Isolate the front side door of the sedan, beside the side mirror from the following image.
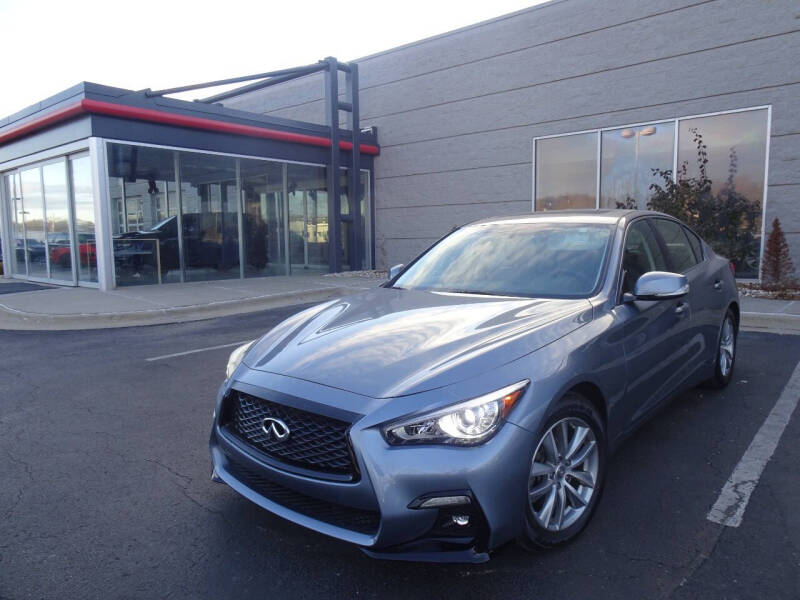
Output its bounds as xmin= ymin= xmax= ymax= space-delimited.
xmin=617 ymin=218 xmax=692 ymax=428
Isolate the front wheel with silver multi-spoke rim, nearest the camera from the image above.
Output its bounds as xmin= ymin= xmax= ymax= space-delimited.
xmin=519 ymin=392 xmax=607 ymax=550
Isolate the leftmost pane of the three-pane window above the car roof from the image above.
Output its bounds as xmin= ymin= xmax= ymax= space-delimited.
xmin=535 ymin=132 xmax=597 ymax=210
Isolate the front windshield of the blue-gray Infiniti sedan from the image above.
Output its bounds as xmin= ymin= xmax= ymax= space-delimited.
xmin=392 ymin=222 xmax=612 ymax=298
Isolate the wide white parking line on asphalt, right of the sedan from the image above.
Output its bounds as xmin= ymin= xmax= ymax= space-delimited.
xmin=706 ymin=363 xmax=800 ymax=527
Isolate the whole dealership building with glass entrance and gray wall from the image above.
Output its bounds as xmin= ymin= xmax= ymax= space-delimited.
xmin=0 ymin=0 xmax=800 ymax=289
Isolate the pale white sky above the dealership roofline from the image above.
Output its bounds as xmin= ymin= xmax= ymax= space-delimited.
xmin=0 ymin=0 xmax=545 ymax=116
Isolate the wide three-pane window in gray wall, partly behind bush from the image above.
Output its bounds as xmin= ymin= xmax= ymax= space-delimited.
xmin=534 ymin=108 xmax=769 ymax=278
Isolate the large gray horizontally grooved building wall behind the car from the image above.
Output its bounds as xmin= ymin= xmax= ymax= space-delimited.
xmin=222 ymin=0 xmax=800 ymax=266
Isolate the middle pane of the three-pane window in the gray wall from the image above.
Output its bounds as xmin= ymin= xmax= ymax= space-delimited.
xmin=600 ymin=122 xmax=675 ymax=210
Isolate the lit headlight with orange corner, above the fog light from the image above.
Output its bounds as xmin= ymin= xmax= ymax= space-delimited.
xmin=383 ymin=379 xmax=530 ymax=446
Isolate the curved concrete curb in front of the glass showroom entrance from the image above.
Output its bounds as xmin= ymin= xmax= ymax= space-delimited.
xmin=0 ymin=287 xmax=354 ymax=331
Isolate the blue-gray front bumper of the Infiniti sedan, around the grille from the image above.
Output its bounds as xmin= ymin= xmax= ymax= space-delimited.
xmin=210 ymin=371 xmax=534 ymax=562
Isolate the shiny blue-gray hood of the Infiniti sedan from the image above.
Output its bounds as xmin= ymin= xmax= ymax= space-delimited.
xmin=244 ymin=288 xmax=592 ymax=398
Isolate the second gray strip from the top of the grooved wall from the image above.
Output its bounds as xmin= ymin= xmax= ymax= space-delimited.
xmin=256 ymin=0 xmax=797 ymax=129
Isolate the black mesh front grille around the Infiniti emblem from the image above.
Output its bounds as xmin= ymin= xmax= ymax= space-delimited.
xmin=223 ymin=390 xmax=356 ymax=478
